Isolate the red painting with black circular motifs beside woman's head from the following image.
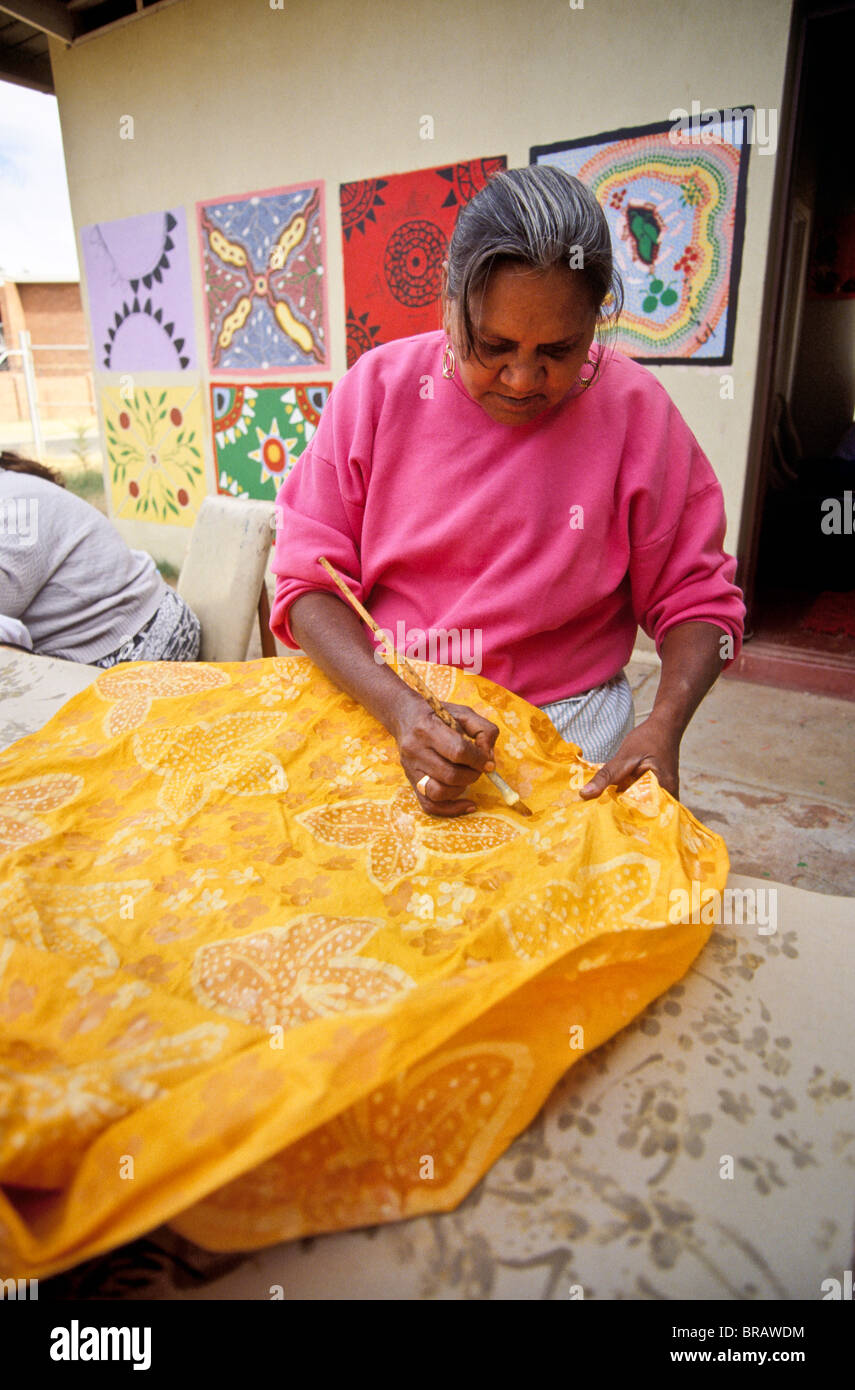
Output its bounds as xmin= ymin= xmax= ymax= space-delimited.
xmin=339 ymin=156 xmax=507 ymax=367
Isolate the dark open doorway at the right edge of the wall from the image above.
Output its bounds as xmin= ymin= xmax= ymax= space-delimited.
xmin=733 ymin=3 xmax=855 ymax=699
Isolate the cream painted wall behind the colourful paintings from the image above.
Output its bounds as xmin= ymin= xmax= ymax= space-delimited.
xmin=51 ymin=0 xmax=791 ymax=563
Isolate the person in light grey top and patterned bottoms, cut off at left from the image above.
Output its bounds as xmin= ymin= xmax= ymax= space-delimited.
xmin=0 ymin=453 xmax=200 ymax=666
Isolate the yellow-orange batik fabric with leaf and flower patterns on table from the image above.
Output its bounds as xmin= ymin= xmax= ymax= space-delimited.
xmin=0 ymin=657 xmax=727 ymax=1277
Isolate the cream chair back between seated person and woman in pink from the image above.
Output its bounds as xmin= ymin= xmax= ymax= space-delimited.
xmin=175 ymin=496 xmax=275 ymax=662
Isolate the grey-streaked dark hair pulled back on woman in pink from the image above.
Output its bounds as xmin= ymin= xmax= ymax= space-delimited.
xmin=445 ymin=164 xmax=623 ymax=377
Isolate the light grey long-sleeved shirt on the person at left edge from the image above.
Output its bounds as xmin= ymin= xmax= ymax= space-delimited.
xmin=0 ymin=467 xmax=165 ymax=662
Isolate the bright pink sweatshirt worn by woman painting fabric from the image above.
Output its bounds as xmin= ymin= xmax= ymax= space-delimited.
xmin=271 ymin=332 xmax=745 ymax=705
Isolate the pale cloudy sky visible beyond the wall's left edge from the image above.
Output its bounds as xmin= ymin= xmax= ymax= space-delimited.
xmin=0 ymin=82 xmax=79 ymax=279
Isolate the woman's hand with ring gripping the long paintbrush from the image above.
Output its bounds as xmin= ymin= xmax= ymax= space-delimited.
xmin=393 ymin=699 xmax=499 ymax=816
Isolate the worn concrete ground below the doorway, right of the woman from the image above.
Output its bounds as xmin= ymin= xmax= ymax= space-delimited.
xmin=627 ymin=649 xmax=855 ymax=895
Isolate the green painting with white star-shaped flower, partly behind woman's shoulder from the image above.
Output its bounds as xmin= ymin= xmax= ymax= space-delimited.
xmin=211 ymin=381 xmax=329 ymax=502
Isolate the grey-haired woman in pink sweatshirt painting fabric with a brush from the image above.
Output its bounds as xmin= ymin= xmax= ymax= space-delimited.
xmin=271 ymin=165 xmax=745 ymax=816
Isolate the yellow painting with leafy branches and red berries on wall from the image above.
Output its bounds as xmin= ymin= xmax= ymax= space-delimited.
xmin=101 ymin=386 xmax=207 ymax=527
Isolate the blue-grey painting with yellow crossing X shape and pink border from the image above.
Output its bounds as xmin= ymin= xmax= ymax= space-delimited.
xmin=197 ymin=183 xmax=329 ymax=375
